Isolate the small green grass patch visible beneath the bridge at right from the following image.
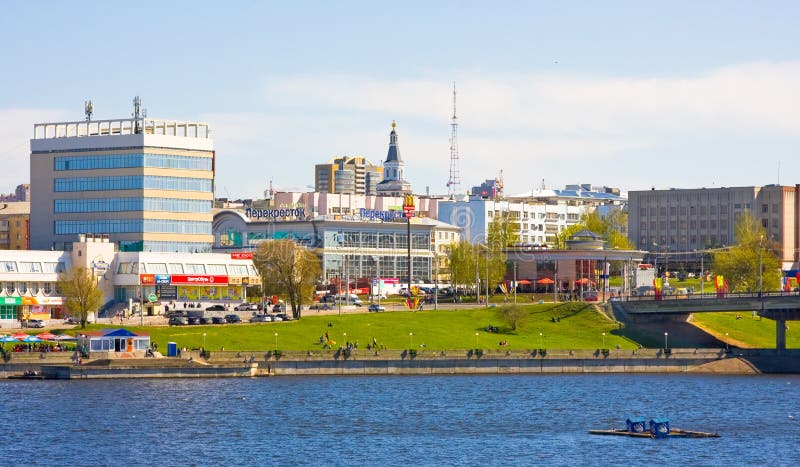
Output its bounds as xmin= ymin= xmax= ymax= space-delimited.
xmin=692 ymin=311 xmax=800 ymax=348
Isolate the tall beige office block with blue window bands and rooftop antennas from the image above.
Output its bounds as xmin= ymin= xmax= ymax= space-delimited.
xmin=30 ymin=117 xmax=215 ymax=252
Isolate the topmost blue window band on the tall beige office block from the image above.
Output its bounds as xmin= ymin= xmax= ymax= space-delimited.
xmin=53 ymin=153 xmax=211 ymax=171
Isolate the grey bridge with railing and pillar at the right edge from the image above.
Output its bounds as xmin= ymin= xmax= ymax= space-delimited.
xmin=611 ymin=292 xmax=800 ymax=351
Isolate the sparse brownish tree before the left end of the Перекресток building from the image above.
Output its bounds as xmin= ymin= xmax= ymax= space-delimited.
xmin=253 ymin=240 xmax=322 ymax=319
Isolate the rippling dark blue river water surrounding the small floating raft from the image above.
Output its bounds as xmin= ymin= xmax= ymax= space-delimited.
xmin=0 ymin=375 xmax=800 ymax=466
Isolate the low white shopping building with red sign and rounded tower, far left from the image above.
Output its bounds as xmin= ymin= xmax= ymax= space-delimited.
xmin=0 ymin=235 xmax=261 ymax=327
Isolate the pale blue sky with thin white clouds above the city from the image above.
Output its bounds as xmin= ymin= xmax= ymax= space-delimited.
xmin=0 ymin=0 xmax=800 ymax=198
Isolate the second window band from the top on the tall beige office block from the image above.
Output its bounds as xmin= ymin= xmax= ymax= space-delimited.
xmin=53 ymin=175 xmax=211 ymax=192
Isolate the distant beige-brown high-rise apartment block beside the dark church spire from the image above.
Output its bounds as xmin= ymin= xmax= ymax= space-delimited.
xmin=314 ymin=156 xmax=383 ymax=195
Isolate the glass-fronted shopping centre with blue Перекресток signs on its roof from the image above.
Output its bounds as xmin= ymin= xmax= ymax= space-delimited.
xmin=214 ymin=208 xmax=460 ymax=283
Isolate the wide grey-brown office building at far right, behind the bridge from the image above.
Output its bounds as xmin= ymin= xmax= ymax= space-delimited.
xmin=628 ymin=185 xmax=800 ymax=270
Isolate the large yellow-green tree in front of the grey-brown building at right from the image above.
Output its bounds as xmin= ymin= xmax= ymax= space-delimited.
xmin=713 ymin=211 xmax=781 ymax=292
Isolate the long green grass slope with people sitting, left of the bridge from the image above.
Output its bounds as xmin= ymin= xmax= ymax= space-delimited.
xmin=72 ymin=303 xmax=637 ymax=351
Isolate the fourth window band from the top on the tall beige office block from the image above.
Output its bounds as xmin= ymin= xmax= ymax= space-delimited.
xmin=54 ymin=219 xmax=211 ymax=235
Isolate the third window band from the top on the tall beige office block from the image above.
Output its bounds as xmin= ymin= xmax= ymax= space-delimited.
xmin=54 ymin=198 xmax=212 ymax=213
